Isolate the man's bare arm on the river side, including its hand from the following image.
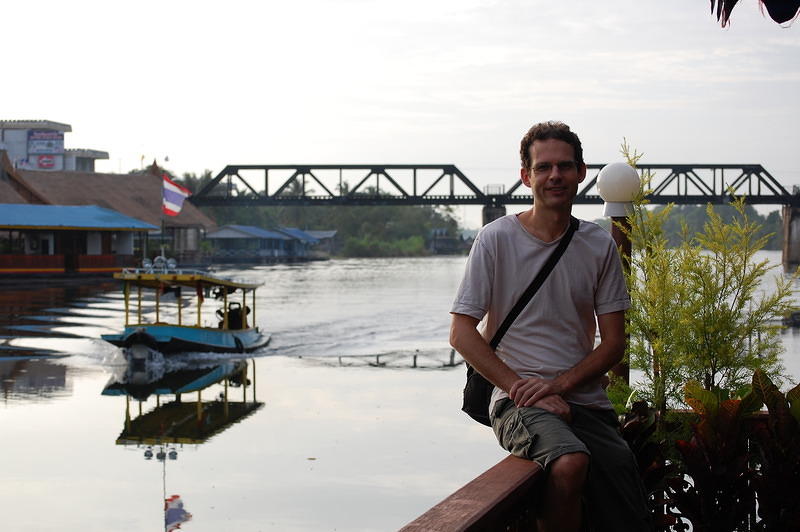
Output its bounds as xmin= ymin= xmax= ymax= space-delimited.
xmin=450 ymin=314 xmax=576 ymax=421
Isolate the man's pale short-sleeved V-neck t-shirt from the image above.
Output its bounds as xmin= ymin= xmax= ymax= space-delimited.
xmin=450 ymin=214 xmax=630 ymax=408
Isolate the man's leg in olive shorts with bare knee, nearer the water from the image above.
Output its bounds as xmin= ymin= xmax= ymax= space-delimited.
xmin=492 ymin=399 xmax=589 ymax=532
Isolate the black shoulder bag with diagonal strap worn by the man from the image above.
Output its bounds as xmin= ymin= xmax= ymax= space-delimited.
xmin=461 ymin=216 xmax=579 ymax=427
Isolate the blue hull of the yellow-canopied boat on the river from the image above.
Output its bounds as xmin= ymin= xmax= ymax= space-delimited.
xmin=102 ymin=325 xmax=270 ymax=355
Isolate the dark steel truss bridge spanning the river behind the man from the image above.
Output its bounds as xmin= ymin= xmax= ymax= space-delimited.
xmin=190 ymin=164 xmax=800 ymax=207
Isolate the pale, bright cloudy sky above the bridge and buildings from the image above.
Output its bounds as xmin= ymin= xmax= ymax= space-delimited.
xmin=0 ymin=0 xmax=800 ymax=226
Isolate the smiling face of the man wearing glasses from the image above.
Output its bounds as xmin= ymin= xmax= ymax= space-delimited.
xmin=520 ymin=139 xmax=586 ymax=208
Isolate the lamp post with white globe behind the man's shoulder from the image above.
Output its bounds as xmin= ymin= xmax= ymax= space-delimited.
xmin=597 ymin=162 xmax=641 ymax=383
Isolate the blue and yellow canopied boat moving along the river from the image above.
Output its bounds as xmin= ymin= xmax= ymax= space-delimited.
xmin=102 ymin=257 xmax=270 ymax=360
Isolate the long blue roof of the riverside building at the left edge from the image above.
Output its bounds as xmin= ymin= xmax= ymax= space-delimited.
xmin=0 ymin=203 xmax=158 ymax=231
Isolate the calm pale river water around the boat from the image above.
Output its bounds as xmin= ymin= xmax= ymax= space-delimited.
xmin=0 ymin=252 xmax=800 ymax=531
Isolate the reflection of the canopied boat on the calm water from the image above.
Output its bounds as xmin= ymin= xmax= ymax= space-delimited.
xmin=102 ymin=360 xmax=264 ymax=446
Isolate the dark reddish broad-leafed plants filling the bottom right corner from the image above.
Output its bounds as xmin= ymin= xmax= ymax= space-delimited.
xmin=665 ymin=370 xmax=800 ymax=532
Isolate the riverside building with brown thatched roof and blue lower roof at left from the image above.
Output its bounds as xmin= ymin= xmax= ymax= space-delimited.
xmin=0 ymin=150 xmax=216 ymax=274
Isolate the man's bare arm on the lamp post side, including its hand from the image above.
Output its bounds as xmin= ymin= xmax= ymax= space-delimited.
xmin=508 ymin=310 xmax=626 ymax=406
